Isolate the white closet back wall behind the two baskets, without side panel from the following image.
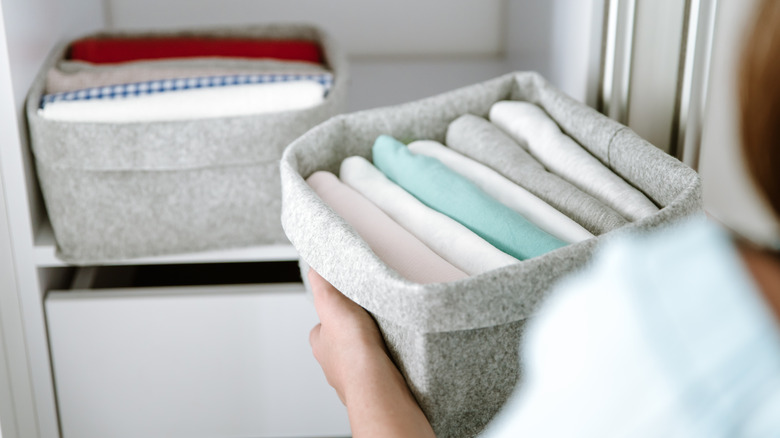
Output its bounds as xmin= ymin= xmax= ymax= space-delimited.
xmin=106 ymin=0 xmax=516 ymax=111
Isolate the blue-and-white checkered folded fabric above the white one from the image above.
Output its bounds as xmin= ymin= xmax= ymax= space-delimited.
xmin=40 ymin=73 xmax=333 ymax=108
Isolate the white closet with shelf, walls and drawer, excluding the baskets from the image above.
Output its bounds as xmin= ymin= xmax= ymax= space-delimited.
xmin=0 ymin=0 xmax=720 ymax=438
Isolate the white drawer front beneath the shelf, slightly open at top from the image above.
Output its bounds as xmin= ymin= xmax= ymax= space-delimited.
xmin=45 ymin=284 xmax=350 ymax=438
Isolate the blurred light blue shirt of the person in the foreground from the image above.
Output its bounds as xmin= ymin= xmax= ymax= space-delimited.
xmin=482 ymin=222 xmax=780 ymax=438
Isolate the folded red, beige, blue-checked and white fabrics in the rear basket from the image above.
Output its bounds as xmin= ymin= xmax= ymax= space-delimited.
xmin=38 ymin=36 xmax=333 ymax=123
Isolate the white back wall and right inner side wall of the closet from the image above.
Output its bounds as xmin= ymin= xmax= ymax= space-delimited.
xmin=106 ymin=0 xmax=603 ymax=111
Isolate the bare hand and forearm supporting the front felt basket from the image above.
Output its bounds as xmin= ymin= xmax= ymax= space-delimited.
xmin=309 ymin=270 xmax=434 ymax=438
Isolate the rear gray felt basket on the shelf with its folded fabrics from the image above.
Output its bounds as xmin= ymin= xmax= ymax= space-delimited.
xmin=26 ymin=24 xmax=348 ymax=264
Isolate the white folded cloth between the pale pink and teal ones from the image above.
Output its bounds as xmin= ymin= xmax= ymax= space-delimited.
xmin=339 ymin=156 xmax=518 ymax=275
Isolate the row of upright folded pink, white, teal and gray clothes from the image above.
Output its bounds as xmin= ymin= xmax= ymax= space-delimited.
xmin=306 ymin=101 xmax=658 ymax=283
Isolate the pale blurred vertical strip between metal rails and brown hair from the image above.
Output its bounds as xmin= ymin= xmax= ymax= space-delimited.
xmin=699 ymin=0 xmax=780 ymax=242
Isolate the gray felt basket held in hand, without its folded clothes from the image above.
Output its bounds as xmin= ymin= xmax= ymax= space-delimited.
xmin=281 ymin=73 xmax=701 ymax=437
